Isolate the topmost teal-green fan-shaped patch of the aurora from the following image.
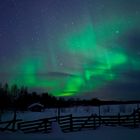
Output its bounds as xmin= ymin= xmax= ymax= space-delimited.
xmin=62 ymin=25 xmax=96 ymax=55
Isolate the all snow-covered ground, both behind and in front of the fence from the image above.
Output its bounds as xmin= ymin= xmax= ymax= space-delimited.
xmin=0 ymin=104 xmax=140 ymax=140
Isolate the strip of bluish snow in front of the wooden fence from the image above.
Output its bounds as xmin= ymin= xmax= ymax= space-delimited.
xmin=0 ymin=127 xmax=140 ymax=140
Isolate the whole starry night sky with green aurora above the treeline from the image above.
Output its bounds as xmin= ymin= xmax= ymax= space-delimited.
xmin=0 ymin=0 xmax=140 ymax=99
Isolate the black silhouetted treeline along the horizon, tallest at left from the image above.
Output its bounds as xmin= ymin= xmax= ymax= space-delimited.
xmin=0 ymin=83 xmax=140 ymax=111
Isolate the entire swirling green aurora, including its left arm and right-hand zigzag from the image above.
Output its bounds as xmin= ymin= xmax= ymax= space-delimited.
xmin=9 ymin=21 xmax=127 ymax=96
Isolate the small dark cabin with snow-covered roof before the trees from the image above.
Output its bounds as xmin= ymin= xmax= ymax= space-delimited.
xmin=28 ymin=103 xmax=44 ymax=112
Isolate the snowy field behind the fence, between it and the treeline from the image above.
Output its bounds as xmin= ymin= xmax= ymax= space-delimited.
xmin=1 ymin=104 xmax=140 ymax=121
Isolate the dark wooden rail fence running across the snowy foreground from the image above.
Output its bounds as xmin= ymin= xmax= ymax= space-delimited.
xmin=0 ymin=108 xmax=140 ymax=133
